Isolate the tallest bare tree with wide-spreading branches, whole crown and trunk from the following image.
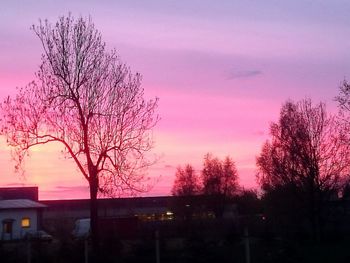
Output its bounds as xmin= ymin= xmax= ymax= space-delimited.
xmin=1 ymin=15 xmax=158 ymax=251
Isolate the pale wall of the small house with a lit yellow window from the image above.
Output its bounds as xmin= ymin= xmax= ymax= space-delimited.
xmin=0 ymin=209 xmax=38 ymax=240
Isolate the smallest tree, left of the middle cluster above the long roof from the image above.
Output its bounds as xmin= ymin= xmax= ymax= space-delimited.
xmin=171 ymin=164 xmax=200 ymax=196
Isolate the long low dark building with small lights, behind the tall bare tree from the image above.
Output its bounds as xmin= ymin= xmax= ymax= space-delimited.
xmin=41 ymin=196 xmax=238 ymax=238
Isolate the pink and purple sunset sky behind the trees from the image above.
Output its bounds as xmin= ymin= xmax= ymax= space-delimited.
xmin=0 ymin=0 xmax=350 ymax=199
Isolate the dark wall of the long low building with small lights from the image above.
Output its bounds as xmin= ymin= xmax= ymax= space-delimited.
xmin=41 ymin=196 xmax=238 ymax=240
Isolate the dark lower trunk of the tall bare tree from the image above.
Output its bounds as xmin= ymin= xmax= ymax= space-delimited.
xmin=89 ymin=175 xmax=99 ymax=258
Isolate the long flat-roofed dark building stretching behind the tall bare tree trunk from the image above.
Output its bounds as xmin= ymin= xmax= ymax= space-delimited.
xmin=41 ymin=196 xmax=230 ymax=224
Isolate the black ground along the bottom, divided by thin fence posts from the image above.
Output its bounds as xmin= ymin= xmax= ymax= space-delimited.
xmin=0 ymin=236 xmax=350 ymax=263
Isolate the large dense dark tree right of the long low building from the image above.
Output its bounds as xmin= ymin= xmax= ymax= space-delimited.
xmin=257 ymin=99 xmax=350 ymax=241
